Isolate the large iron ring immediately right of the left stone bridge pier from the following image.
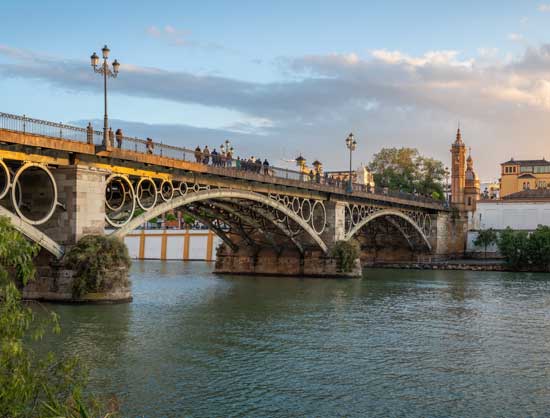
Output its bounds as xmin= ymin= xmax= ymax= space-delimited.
xmin=105 ymin=174 xmax=137 ymax=228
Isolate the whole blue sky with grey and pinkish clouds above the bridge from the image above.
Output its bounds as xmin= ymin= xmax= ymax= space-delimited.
xmin=0 ymin=0 xmax=550 ymax=180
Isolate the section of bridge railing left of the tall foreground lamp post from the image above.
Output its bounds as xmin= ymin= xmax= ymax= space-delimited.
xmin=0 ymin=112 xmax=103 ymax=144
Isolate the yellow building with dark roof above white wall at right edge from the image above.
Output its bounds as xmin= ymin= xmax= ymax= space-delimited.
xmin=500 ymin=158 xmax=550 ymax=198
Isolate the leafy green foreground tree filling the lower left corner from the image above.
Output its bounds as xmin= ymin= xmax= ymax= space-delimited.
xmin=0 ymin=217 xmax=116 ymax=418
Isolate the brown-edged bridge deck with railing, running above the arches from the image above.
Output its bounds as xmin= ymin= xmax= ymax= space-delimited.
xmin=0 ymin=113 xmax=447 ymax=211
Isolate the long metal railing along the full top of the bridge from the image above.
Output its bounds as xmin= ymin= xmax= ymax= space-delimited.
xmin=0 ymin=112 xmax=447 ymax=208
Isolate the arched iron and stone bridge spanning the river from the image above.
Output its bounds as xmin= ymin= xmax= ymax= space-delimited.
xmin=0 ymin=113 xmax=463 ymax=298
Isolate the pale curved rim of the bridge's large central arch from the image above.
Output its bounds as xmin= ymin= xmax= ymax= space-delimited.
xmin=111 ymin=189 xmax=328 ymax=253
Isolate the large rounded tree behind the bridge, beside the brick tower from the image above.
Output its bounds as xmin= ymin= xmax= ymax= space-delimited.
xmin=369 ymin=148 xmax=445 ymax=199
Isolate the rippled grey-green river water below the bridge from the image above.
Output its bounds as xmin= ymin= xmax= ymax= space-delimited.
xmin=41 ymin=261 xmax=550 ymax=417
